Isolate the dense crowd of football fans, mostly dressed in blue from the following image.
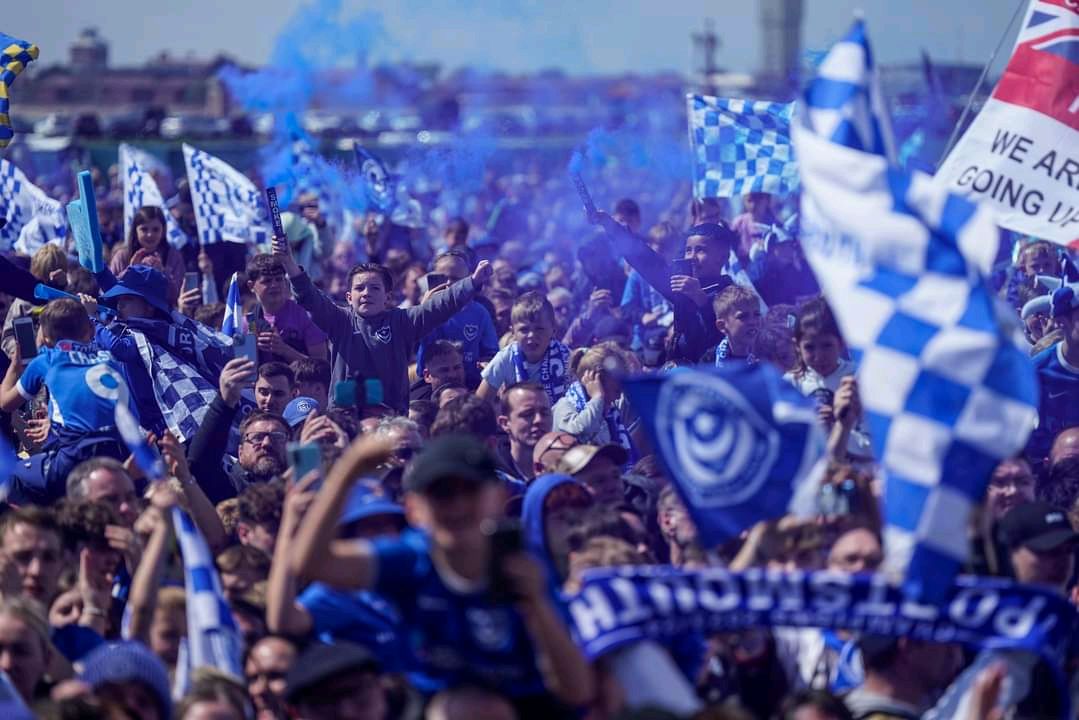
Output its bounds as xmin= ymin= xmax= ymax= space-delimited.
xmin=0 ymin=147 xmax=1079 ymax=720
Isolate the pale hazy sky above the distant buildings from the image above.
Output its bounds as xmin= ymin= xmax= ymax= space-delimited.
xmin=0 ymin=0 xmax=1026 ymax=74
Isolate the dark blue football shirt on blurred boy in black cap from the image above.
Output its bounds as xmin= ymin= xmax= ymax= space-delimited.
xmin=373 ymin=531 xmax=546 ymax=697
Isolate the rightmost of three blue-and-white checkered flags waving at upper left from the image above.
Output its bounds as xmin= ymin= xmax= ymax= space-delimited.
xmin=183 ymin=145 xmax=273 ymax=245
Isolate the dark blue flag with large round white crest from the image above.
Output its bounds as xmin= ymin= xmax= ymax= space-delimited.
xmin=624 ymin=363 xmax=824 ymax=546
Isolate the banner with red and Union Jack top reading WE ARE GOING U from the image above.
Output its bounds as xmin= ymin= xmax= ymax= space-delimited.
xmin=938 ymin=0 xmax=1079 ymax=244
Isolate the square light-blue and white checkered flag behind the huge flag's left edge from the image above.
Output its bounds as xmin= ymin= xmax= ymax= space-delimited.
xmin=686 ymin=95 xmax=798 ymax=198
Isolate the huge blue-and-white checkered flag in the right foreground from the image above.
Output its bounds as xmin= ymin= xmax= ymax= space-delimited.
xmin=792 ymin=21 xmax=1038 ymax=601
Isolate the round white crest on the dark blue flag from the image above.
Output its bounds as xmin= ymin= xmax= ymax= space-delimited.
xmin=656 ymin=372 xmax=780 ymax=508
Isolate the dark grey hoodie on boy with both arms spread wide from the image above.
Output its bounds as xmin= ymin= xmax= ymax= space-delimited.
xmin=292 ymin=272 xmax=476 ymax=413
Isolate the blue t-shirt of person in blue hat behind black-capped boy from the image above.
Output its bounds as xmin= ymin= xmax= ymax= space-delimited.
xmin=297 ymin=583 xmax=408 ymax=673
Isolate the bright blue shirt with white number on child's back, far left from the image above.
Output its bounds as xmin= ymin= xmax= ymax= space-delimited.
xmin=15 ymin=340 xmax=129 ymax=432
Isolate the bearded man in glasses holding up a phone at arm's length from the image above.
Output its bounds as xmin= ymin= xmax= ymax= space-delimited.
xmin=188 ymin=357 xmax=288 ymax=505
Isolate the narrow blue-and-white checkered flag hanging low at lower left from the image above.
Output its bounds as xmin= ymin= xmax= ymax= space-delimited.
xmin=173 ymin=507 xmax=244 ymax=694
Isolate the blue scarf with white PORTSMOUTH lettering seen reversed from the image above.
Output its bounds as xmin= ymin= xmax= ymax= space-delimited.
xmin=566 ymin=566 xmax=1079 ymax=706
